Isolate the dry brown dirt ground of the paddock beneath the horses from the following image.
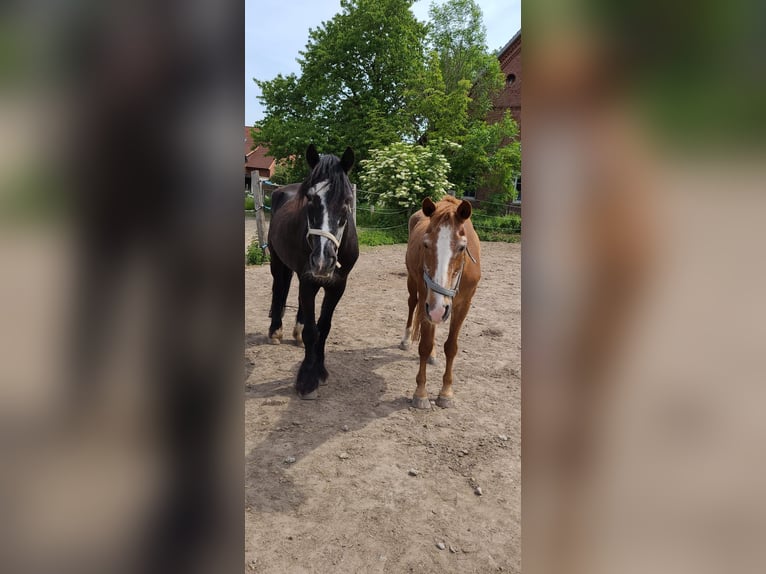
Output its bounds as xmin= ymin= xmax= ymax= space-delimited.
xmin=245 ymin=221 xmax=521 ymax=574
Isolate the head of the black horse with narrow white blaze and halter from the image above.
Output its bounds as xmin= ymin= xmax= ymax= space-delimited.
xmin=300 ymin=144 xmax=354 ymax=279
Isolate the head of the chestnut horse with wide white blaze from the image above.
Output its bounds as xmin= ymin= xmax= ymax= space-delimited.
xmin=422 ymin=196 xmax=471 ymax=323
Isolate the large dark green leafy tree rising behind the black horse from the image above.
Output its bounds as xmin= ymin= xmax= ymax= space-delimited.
xmin=255 ymin=0 xmax=426 ymax=176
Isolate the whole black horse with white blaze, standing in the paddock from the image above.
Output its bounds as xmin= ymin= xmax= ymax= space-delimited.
xmin=269 ymin=144 xmax=359 ymax=399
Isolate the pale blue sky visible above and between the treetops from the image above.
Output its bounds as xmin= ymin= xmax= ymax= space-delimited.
xmin=245 ymin=0 xmax=521 ymax=125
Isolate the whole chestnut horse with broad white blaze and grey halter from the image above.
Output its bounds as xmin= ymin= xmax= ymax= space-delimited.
xmin=400 ymin=196 xmax=481 ymax=409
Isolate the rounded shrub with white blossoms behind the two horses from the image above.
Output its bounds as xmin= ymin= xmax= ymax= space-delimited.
xmin=359 ymin=143 xmax=451 ymax=211
